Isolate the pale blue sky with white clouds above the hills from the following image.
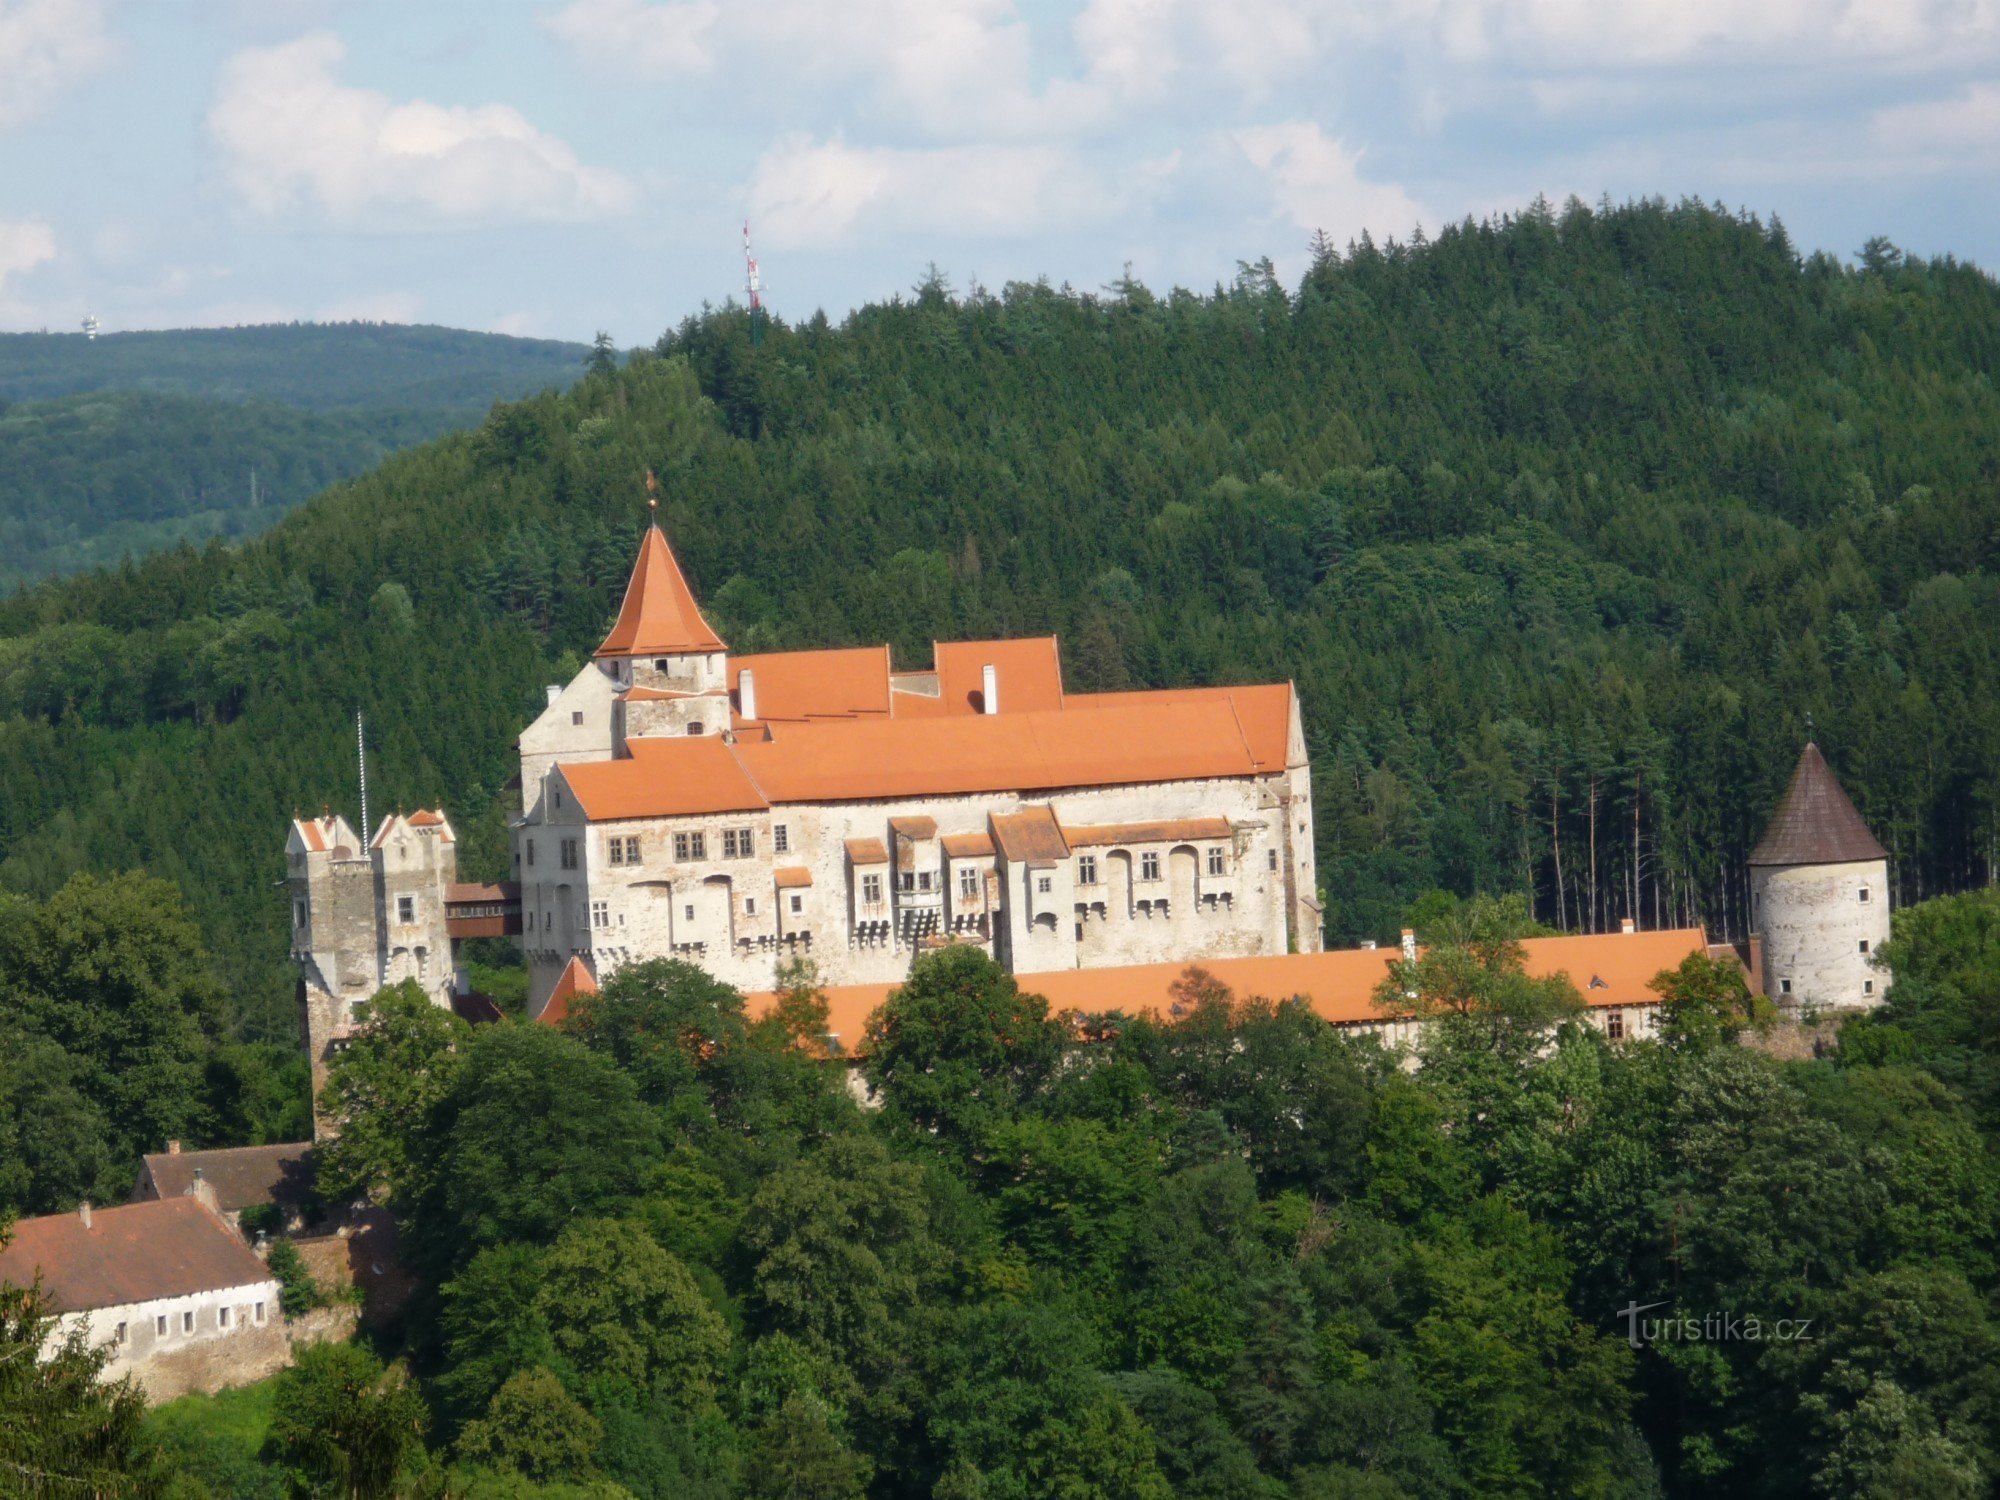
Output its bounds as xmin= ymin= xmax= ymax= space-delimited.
xmin=0 ymin=0 xmax=2000 ymax=346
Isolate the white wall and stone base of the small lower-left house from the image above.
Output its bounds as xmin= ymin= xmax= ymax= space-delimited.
xmin=50 ymin=1280 xmax=288 ymax=1402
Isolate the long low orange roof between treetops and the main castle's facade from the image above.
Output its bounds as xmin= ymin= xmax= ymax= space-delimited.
xmin=750 ymin=928 xmax=1708 ymax=1054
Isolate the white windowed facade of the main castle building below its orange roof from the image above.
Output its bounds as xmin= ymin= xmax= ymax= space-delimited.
xmin=516 ymin=772 xmax=1318 ymax=1008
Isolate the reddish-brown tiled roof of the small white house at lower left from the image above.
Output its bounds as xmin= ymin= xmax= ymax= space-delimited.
xmin=0 ymin=1198 xmax=272 ymax=1312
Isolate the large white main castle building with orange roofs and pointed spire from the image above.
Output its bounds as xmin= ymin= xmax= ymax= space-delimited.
xmin=514 ymin=526 xmax=1320 ymax=1012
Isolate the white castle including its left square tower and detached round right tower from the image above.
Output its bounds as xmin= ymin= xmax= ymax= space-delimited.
xmin=286 ymin=512 xmax=1888 ymax=1112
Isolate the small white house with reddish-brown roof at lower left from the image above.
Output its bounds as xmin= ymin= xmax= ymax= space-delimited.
xmin=0 ymin=1194 xmax=290 ymax=1402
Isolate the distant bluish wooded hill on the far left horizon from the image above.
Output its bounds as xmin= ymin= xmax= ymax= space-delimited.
xmin=0 ymin=322 xmax=588 ymax=586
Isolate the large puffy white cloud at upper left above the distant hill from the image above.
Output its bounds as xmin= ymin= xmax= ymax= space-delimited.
xmin=208 ymin=32 xmax=632 ymax=228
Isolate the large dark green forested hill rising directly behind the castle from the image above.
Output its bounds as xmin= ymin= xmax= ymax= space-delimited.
xmin=0 ymin=204 xmax=2000 ymax=1032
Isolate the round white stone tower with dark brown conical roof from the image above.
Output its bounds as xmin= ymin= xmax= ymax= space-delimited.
xmin=1750 ymin=744 xmax=1888 ymax=1006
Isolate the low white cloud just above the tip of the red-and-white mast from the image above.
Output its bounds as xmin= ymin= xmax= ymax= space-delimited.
xmin=750 ymin=136 xmax=1116 ymax=248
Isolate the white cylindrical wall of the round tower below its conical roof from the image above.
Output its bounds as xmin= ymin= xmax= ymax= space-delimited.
xmin=1750 ymin=860 xmax=1890 ymax=1006
